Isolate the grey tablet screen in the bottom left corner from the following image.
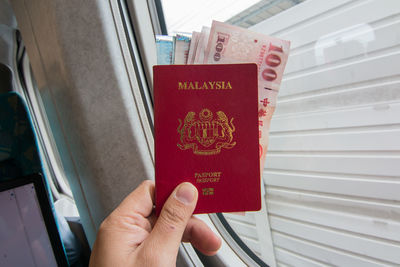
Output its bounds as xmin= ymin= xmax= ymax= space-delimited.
xmin=0 ymin=183 xmax=57 ymax=267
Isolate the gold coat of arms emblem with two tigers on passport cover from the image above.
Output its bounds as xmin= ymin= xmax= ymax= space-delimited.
xmin=177 ymin=108 xmax=236 ymax=155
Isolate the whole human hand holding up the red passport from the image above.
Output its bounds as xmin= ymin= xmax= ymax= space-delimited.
xmin=89 ymin=181 xmax=221 ymax=267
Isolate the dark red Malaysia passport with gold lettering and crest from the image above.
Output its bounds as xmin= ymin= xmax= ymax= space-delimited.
xmin=153 ymin=64 xmax=261 ymax=215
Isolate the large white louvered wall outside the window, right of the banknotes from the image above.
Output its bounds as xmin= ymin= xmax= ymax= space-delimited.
xmin=254 ymin=0 xmax=400 ymax=266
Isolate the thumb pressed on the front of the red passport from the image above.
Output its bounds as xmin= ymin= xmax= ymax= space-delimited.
xmin=146 ymin=183 xmax=198 ymax=264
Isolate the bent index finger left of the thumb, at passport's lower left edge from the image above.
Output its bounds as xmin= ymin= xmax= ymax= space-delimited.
xmin=115 ymin=180 xmax=155 ymax=218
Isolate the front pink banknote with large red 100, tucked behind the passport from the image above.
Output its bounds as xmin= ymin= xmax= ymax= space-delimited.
xmin=203 ymin=21 xmax=290 ymax=168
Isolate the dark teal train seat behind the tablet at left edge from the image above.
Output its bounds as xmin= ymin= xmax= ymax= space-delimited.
xmin=0 ymin=92 xmax=81 ymax=266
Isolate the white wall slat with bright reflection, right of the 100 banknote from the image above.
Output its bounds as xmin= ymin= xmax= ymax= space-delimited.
xmin=285 ymin=15 xmax=400 ymax=75
